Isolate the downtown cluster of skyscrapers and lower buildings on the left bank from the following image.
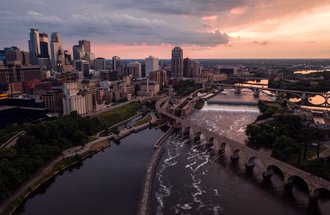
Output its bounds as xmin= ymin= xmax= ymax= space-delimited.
xmin=0 ymin=28 xmax=229 ymax=126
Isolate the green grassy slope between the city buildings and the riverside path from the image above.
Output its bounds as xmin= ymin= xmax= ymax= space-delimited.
xmin=97 ymin=102 xmax=142 ymax=128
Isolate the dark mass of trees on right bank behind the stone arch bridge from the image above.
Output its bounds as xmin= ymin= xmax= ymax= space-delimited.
xmin=246 ymin=101 xmax=330 ymax=180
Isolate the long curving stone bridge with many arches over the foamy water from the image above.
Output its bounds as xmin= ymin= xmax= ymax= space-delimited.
xmin=156 ymin=97 xmax=330 ymax=200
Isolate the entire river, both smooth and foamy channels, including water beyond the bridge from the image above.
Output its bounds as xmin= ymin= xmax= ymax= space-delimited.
xmin=16 ymin=90 xmax=330 ymax=215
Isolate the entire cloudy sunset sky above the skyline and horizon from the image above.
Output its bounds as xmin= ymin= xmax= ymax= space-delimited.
xmin=0 ymin=0 xmax=330 ymax=59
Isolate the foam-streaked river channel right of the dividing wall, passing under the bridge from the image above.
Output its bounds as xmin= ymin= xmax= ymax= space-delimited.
xmin=151 ymin=90 xmax=330 ymax=215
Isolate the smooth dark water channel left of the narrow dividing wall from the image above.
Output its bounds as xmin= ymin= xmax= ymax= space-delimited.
xmin=16 ymin=129 xmax=162 ymax=215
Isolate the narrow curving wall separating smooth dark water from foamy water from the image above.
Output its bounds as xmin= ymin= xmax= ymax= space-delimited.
xmin=138 ymin=128 xmax=174 ymax=215
